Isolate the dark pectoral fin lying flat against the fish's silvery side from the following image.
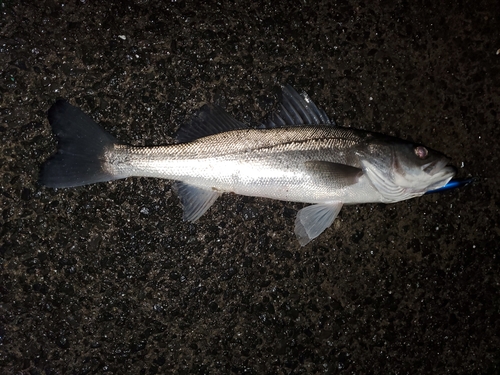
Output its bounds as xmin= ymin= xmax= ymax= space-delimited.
xmin=304 ymin=160 xmax=363 ymax=189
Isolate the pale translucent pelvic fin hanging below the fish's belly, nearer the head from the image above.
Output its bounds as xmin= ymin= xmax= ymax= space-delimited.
xmin=295 ymin=202 xmax=342 ymax=246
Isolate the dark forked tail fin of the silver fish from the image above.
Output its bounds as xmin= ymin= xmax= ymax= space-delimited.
xmin=40 ymin=100 xmax=120 ymax=188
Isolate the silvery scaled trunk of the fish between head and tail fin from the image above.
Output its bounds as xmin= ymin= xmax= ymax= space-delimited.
xmin=106 ymin=126 xmax=390 ymax=204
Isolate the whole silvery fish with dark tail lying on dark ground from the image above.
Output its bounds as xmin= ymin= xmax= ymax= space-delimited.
xmin=40 ymin=85 xmax=456 ymax=246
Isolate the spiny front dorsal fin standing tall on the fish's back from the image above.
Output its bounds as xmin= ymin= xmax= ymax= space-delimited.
xmin=263 ymin=85 xmax=335 ymax=128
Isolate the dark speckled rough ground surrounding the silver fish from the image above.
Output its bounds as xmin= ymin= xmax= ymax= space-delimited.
xmin=0 ymin=0 xmax=500 ymax=374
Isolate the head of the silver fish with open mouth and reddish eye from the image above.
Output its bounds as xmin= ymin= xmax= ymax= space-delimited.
xmin=361 ymin=137 xmax=456 ymax=203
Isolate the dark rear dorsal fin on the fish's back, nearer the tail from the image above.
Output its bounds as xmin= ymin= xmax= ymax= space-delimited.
xmin=176 ymin=104 xmax=247 ymax=143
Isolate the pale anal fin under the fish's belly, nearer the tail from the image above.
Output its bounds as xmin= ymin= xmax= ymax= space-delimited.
xmin=172 ymin=182 xmax=220 ymax=222
